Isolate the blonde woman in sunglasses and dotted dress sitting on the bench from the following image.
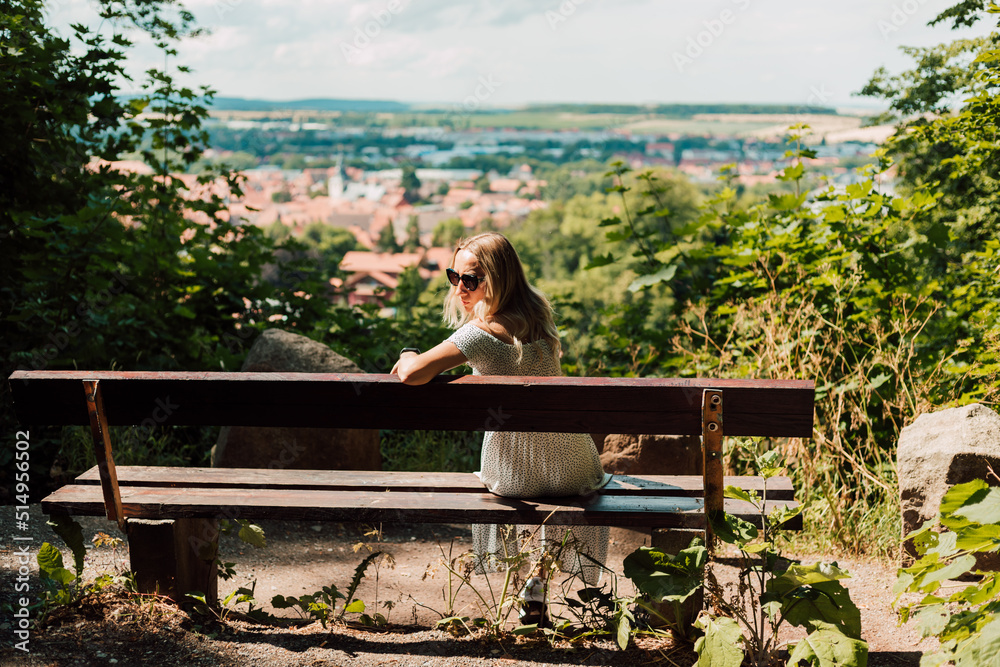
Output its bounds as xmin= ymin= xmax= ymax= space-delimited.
xmin=392 ymin=232 xmax=611 ymax=625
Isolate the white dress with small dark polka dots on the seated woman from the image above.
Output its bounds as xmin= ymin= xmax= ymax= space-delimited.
xmin=448 ymin=322 xmax=611 ymax=584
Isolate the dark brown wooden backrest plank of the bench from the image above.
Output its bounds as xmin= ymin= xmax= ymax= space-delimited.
xmin=10 ymin=371 xmax=814 ymax=437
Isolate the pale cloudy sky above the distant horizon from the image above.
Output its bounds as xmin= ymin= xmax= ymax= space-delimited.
xmin=43 ymin=0 xmax=992 ymax=109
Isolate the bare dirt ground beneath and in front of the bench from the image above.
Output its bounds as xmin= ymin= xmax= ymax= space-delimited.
xmin=0 ymin=507 xmax=934 ymax=667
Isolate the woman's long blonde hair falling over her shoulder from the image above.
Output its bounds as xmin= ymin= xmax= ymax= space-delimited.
xmin=444 ymin=232 xmax=561 ymax=359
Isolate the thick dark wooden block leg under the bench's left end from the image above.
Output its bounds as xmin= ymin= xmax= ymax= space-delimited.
xmin=126 ymin=519 xmax=219 ymax=605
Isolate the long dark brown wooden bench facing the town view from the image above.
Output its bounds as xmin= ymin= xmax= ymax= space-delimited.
xmin=10 ymin=371 xmax=814 ymax=600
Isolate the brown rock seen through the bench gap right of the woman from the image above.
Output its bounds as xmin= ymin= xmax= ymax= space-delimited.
xmin=601 ymin=434 xmax=704 ymax=475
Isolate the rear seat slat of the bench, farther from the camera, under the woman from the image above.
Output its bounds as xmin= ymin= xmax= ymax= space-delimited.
xmin=76 ymin=466 xmax=794 ymax=500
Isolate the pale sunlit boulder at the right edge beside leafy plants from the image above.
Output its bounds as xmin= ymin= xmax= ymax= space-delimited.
xmin=896 ymin=403 xmax=1000 ymax=569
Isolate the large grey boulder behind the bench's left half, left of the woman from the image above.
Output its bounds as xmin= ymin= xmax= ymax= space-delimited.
xmin=212 ymin=329 xmax=382 ymax=470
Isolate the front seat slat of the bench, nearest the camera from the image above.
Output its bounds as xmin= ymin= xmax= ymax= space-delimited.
xmin=42 ymin=484 xmax=801 ymax=528
